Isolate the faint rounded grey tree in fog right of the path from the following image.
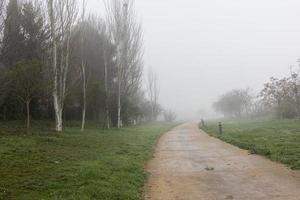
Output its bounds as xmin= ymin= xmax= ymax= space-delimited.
xmin=213 ymin=89 xmax=253 ymax=117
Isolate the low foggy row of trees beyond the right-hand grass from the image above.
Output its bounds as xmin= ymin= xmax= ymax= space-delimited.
xmin=213 ymin=63 xmax=300 ymax=119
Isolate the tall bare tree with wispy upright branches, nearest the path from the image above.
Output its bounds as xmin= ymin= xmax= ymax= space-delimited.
xmin=106 ymin=0 xmax=142 ymax=128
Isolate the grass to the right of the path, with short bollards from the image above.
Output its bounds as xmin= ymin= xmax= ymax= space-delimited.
xmin=201 ymin=120 xmax=300 ymax=169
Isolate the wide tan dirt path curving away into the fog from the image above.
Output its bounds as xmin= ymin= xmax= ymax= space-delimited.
xmin=145 ymin=123 xmax=300 ymax=200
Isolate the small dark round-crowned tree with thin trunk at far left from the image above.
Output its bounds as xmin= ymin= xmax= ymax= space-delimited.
xmin=10 ymin=60 xmax=48 ymax=132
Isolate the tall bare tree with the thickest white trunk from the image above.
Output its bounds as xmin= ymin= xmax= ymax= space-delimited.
xmin=48 ymin=0 xmax=78 ymax=132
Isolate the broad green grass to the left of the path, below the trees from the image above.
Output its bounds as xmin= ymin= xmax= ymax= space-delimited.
xmin=0 ymin=122 xmax=174 ymax=200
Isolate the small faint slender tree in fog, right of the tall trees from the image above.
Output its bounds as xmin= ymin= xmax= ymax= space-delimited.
xmin=147 ymin=68 xmax=159 ymax=121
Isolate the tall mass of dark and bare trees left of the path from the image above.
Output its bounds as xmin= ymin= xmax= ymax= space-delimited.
xmin=0 ymin=0 xmax=169 ymax=132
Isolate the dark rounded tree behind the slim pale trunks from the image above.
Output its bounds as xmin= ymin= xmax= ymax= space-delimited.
xmin=65 ymin=16 xmax=117 ymax=128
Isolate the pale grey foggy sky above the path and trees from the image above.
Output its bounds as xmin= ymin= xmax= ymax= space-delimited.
xmin=88 ymin=0 xmax=300 ymax=119
